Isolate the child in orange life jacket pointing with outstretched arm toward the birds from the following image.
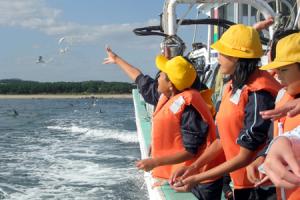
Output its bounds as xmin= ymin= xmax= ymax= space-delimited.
xmin=104 ymin=48 xmax=223 ymax=199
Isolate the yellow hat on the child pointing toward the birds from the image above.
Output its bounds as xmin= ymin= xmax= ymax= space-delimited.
xmin=156 ymin=55 xmax=197 ymax=91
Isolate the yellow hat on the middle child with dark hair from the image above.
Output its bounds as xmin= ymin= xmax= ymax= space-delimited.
xmin=211 ymin=24 xmax=263 ymax=58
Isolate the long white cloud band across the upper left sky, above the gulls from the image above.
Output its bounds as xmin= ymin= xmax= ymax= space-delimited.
xmin=0 ymin=0 xmax=159 ymax=43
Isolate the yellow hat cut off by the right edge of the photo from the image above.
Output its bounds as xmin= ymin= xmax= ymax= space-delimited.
xmin=260 ymin=33 xmax=300 ymax=70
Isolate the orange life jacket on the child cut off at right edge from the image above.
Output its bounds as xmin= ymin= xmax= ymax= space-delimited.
xmin=274 ymin=89 xmax=300 ymax=200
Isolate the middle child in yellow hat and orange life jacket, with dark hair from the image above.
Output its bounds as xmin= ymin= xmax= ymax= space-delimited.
xmin=174 ymin=24 xmax=280 ymax=200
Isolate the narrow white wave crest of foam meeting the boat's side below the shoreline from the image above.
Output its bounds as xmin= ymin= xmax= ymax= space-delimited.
xmin=47 ymin=124 xmax=138 ymax=143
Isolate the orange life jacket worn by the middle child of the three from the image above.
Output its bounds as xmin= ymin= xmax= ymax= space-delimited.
xmin=216 ymin=70 xmax=280 ymax=189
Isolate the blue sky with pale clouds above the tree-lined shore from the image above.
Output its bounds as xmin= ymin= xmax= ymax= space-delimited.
xmin=0 ymin=0 xmax=206 ymax=82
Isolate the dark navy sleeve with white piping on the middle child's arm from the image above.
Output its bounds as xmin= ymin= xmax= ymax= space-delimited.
xmin=237 ymin=91 xmax=274 ymax=151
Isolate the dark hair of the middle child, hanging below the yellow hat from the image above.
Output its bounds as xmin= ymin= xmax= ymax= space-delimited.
xmin=231 ymin=58 xmax=260 ymax=94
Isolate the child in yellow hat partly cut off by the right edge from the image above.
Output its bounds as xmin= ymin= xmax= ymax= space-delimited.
xmin=261 ymin=33 xmax=300 ymax=200
